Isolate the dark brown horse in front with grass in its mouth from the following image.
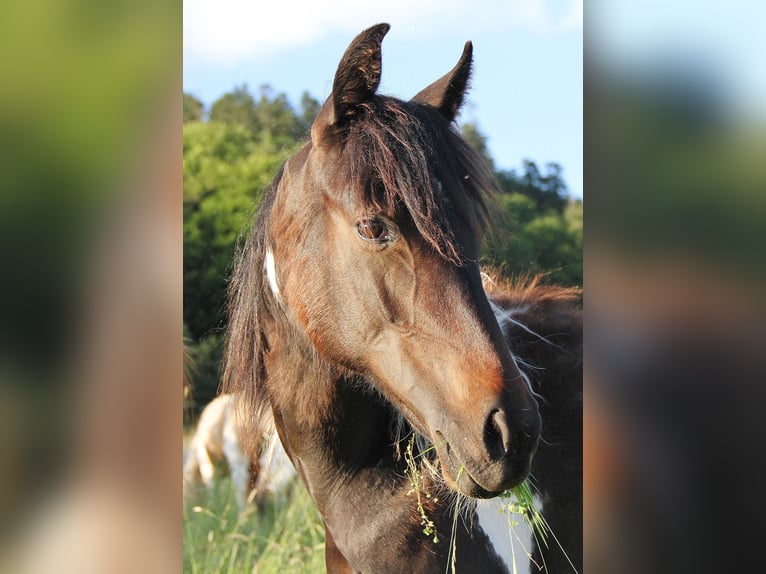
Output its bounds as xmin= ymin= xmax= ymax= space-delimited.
xmin=224 ymin=24 xmax=581 ymax=573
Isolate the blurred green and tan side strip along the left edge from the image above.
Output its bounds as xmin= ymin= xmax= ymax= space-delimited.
xmin=0 ymin=0 xmax=182 ymax=572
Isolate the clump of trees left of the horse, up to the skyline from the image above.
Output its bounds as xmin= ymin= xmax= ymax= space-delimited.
xmin=183 ymin=85 xmax=319 ymax=405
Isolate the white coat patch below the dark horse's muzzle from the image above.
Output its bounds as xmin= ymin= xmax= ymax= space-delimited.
xmin=476 ymin=496 xmax=543 ymax=574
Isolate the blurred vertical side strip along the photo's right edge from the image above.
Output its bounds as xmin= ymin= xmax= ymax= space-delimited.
xmin=584 ymin=0 xmax=766 ymax=572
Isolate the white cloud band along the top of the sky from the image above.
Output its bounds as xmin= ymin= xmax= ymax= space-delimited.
xmin=184 ymin=0 xmax=582 ymax=63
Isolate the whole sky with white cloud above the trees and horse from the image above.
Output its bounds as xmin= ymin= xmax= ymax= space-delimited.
xmin=183 ymin=0 xmax=583 ymax=197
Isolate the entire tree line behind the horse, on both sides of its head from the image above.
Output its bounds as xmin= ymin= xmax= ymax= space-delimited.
xmin=183 ymin=85 xmax=582 ymax=418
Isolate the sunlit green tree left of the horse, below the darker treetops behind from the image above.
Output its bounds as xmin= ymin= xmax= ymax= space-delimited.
xmin=183 ymin=122 xmax=302 ymax=407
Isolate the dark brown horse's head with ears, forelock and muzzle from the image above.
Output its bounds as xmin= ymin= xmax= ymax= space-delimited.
xmin=265 ymin=24 xmax=540 ymax=498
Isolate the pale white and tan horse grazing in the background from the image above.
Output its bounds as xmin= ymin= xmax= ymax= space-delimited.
xmin=183 ymin=394 xmax=295 ymax=510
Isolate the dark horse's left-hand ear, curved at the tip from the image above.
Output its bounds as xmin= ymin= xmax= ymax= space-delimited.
xmin=311 ymin=24 xmax=391 ymax=140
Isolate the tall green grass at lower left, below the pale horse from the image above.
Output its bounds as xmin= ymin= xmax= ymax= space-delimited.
xmin=183 ymin=477 xmax=325 ymax=574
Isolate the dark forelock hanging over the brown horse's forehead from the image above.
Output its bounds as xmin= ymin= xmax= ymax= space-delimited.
xmin=336 ymin=96 xmax=496 ymax=264
